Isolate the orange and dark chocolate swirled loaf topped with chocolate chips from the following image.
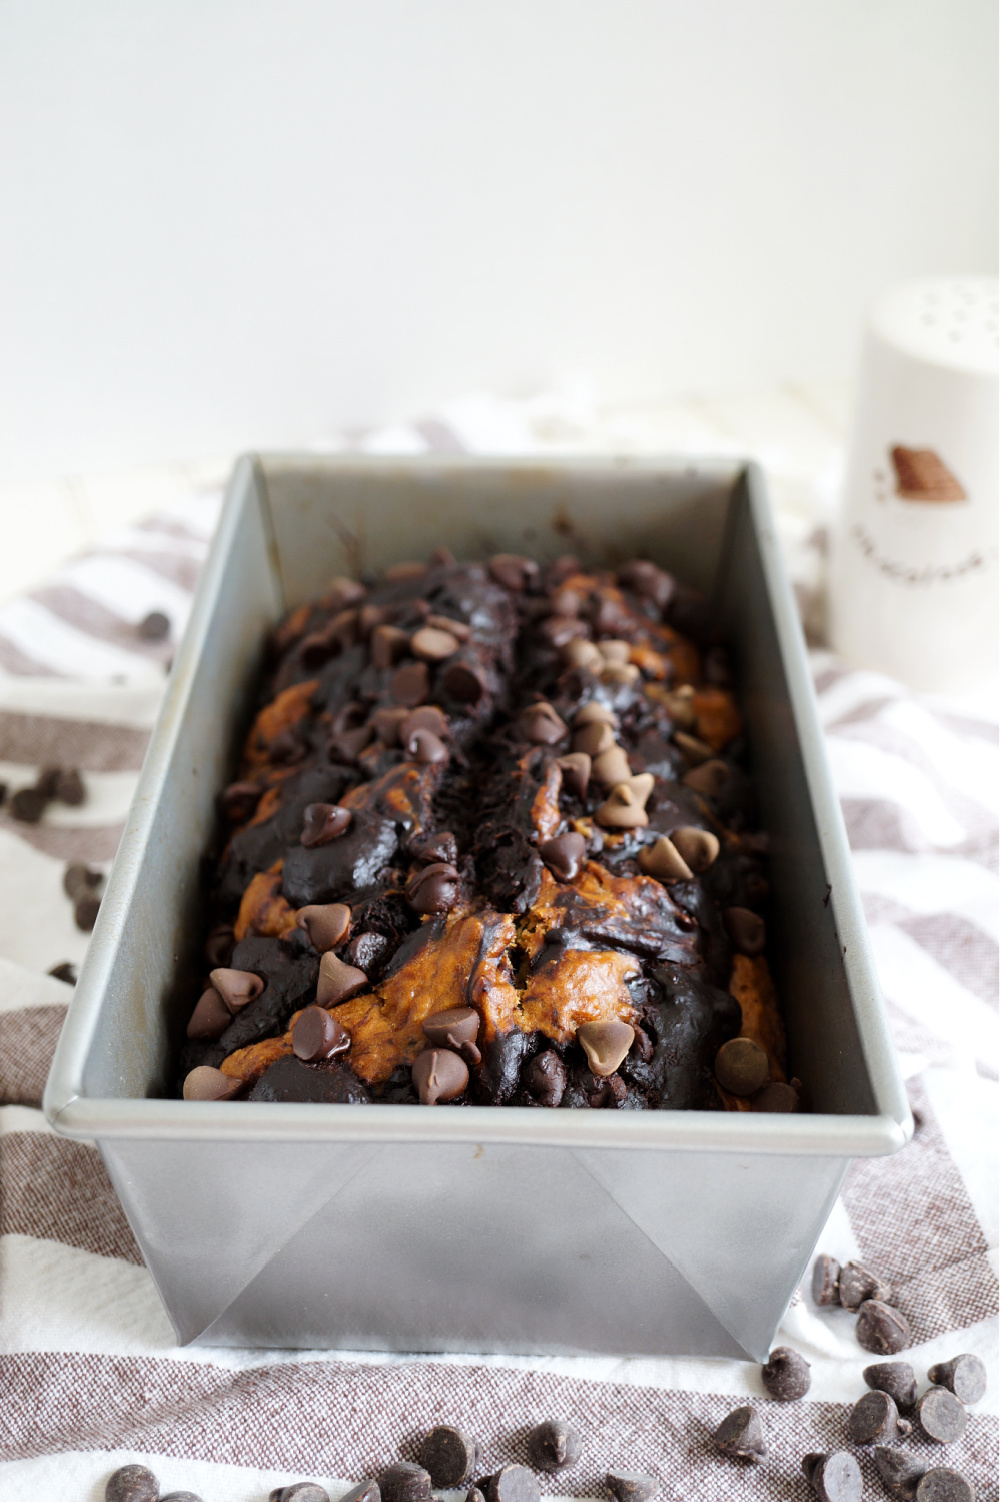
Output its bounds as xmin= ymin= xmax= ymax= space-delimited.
xmin=179 ymin=551 xmax=799 ymax=1110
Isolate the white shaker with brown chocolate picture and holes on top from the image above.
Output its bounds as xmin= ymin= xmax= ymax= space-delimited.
xmin=829 ymin=276 xmax=1000 ymax=691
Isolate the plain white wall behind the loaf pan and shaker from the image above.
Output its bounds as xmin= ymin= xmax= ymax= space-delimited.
xmin=0 ymin=0 xmax=997 ymax=479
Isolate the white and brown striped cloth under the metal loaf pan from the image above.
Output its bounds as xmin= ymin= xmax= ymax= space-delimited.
xmin=0 ymin=424 xmax=998 ymax=1502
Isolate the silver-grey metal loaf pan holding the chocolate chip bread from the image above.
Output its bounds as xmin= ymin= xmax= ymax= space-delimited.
xmin=45 ymin=457 xmax=911 ymax=1359
